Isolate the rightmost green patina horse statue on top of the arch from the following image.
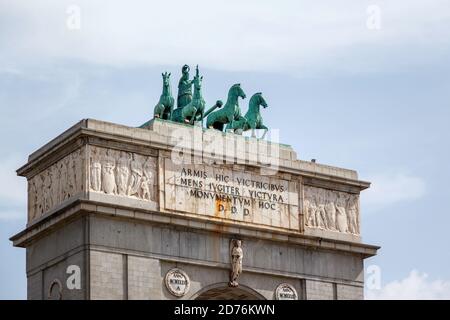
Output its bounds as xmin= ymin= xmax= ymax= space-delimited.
xmin=227 ymin=92 xmax=268 ymax=139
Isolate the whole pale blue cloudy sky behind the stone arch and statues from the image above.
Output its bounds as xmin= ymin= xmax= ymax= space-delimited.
xmin=0 ymin=0 xmax=450 ymax=299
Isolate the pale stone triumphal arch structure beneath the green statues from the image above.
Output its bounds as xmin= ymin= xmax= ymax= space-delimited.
xmin=11 ymin=119 xmax=378 ymax=299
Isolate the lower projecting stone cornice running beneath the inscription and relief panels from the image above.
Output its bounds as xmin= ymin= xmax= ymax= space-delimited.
xmin=10 ymin=200 xmax=380 ymax=258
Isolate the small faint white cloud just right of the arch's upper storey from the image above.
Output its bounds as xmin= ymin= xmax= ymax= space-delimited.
xmin=361 ymin=173 xmax=426 ymax=208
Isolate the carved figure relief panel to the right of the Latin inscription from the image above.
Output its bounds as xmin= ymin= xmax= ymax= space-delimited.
xmin=303 ymin=186 xmax=360 ymax=235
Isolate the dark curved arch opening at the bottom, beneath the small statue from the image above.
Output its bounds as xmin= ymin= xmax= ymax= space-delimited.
xmin=191 ymin=282 xmax=266 ymax=300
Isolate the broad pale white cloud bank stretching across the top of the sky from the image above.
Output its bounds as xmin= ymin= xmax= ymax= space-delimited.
xmin=0 ymin=0 xmax=450 ymax=73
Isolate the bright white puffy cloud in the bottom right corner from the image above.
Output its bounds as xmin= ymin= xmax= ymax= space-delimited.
xmin=365 ymin=270 xmax=450 ymax=300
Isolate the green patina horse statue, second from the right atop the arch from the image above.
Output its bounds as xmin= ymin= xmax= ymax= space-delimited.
xmin=206 ymin=83 xmax=246 ymax=131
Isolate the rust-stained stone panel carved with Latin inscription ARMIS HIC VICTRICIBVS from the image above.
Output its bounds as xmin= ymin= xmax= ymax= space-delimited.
xmin=164 ymin=159 xmax=299 ymax=230
